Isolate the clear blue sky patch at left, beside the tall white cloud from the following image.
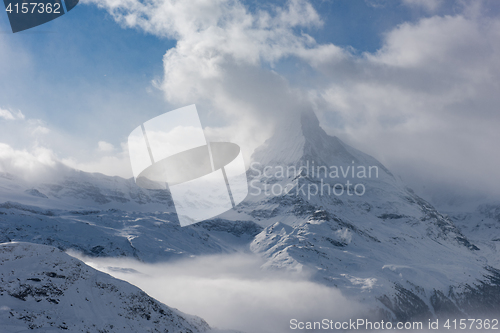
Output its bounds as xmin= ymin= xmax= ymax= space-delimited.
xmin=0 ymin=5 xmax=170 ymax=142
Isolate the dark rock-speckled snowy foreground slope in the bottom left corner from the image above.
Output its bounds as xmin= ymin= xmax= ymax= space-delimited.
xmin=0 ymin=243 xmax=210 ymax=333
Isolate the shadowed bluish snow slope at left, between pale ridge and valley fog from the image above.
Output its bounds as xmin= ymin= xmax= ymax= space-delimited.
xmin=0 ymin=202 xmax=262 ymax=262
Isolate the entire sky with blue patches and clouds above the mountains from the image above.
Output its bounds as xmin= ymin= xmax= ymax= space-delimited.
xmin=0 ymin=0 xmax=500 ymax=206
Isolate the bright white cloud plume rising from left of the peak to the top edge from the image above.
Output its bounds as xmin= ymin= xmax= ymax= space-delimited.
xmin=82 ymin=0 xmax=346 ymax=160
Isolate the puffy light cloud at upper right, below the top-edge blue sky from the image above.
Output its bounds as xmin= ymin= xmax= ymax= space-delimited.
xmin=368 ymin=15 xmax=488 ymax=68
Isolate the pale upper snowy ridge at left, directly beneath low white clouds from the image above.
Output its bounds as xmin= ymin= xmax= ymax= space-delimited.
xmin=0 ymin=165 xmax=174 ymax=212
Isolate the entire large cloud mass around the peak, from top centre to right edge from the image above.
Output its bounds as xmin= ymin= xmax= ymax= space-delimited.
xmin=81 ymin=0 xmax=500 ymax=205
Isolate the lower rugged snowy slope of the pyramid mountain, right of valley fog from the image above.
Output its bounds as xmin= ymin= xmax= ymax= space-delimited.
xmin=251 ymin=211 xmax=500 ymax=320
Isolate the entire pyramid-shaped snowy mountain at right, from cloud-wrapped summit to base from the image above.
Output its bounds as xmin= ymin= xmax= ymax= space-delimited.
xmin=237 ymin=112 xmax=500 ymax=320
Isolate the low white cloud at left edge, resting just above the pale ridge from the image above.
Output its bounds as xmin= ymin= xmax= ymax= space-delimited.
xmin=0 ymin=109 xmax=132 ymax=181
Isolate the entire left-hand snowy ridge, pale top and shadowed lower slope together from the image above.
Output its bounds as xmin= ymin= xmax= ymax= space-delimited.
xmin=0 ymin=161 xmax=262 ymax=262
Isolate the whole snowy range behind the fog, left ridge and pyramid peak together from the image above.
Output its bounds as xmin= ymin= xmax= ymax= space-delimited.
xmin=0 ymin=112 xmax=500 ymax=320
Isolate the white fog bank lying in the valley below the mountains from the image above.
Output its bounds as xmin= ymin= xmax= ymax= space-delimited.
xmin=71 ymin=253 xmax=366 ymax=333
